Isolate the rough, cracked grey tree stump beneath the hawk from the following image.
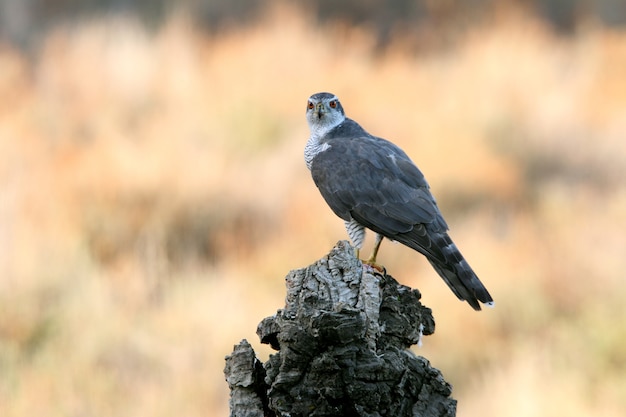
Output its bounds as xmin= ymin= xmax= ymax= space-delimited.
xmin=225 ymin=241 xmax=456 ymax=417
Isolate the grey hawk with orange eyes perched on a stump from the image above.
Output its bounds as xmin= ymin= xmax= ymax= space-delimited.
xmin=304 ymin=93 xmax=493 ymax=310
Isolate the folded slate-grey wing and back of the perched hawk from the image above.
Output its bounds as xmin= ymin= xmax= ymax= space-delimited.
xmin=311 ymin=136 xmax=448 ymax=244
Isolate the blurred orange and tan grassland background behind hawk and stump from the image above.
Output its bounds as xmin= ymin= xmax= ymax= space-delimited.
xmin=0 ymin=0 xmax=626 ymax=417
